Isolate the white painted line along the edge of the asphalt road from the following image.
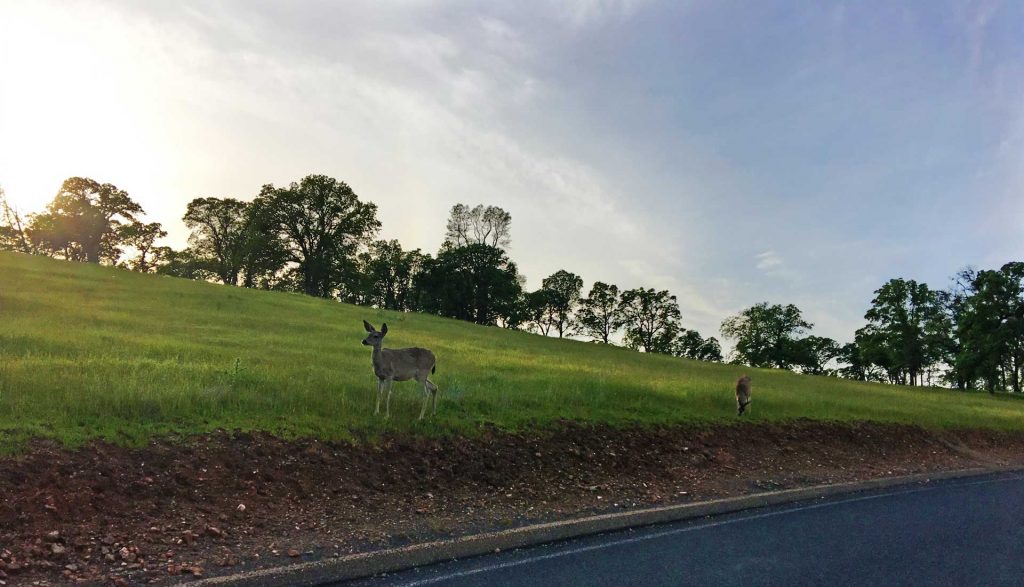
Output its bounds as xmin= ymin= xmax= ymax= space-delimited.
xmin=387 ymin=476 xmax=1024 ymax=587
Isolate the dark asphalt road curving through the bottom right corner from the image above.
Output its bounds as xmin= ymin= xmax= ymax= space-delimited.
xmin=347 ymin=475 xmax=1024 ymax=587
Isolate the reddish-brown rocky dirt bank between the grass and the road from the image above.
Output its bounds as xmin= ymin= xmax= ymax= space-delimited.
xmin=0 ymin=421 xmax=1024 ymax=585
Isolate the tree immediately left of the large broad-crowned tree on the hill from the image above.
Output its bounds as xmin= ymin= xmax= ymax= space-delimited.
xmin=182 ymin=198 xmax=248 ymax=286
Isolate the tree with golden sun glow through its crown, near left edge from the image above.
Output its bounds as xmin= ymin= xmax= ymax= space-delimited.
xmin=27 ymin=177 xmax=143 ymax=263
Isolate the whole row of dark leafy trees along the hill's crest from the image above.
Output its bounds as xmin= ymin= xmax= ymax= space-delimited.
xmin=0 ymin=175 xmax=1024 ymax=392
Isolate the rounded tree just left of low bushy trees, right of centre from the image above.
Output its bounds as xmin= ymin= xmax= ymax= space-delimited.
xmin=618 ymin=288 xmax=681 ymax=353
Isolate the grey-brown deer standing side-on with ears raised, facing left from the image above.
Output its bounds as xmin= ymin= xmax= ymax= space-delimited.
xmin=362 ymin=320 xmax=437 ymax=420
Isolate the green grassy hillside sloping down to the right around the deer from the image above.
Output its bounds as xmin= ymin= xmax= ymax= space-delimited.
xmin=0 ymin=253 xmax=1024 ymax=452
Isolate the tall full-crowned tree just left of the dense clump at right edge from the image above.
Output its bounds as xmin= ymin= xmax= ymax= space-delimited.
xmin=856 ymin=279 xmax=950 ymax=385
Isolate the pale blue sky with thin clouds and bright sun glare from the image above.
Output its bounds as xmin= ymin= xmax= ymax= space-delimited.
xmin=0 ymin=0 xmax=1024 ymax=341
